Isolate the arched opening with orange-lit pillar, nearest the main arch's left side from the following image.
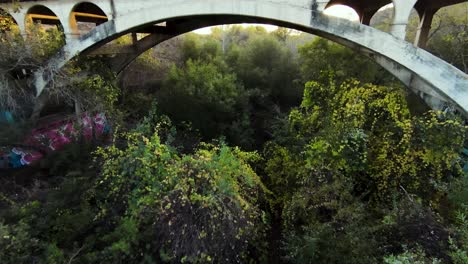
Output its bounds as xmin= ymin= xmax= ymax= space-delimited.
xmin=70 ymin=2 xmax=109 ymax=35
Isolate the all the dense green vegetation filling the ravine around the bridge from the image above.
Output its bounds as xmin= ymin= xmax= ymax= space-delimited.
xmin=0 ymin=3 xmax=468 ymax=263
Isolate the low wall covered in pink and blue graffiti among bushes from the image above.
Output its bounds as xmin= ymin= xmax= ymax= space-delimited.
xmin=0 ymin=113 xmax=110 ymax=169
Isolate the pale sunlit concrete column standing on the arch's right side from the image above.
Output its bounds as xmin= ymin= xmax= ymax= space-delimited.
xmin=390 ymin=0 xmax=417 ymax=39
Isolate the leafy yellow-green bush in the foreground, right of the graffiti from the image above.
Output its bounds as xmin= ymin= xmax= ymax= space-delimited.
xmin=94 ymin=128 xmax=267 ymax=263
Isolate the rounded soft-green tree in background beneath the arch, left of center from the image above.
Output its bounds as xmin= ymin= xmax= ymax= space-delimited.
xmin=157 ymin=60 xmax=251 ymax=145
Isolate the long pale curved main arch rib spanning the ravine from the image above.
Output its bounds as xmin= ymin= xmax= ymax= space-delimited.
xmin=34 ymin=0 xmax=468 ymax=114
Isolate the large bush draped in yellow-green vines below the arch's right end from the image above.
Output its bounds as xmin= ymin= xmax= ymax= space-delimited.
xmin=265 ymin=72 xmax=466 ymax=263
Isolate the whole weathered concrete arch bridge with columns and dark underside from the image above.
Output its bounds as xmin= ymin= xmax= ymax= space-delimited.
xmin=0 ymin=0 xmax=468 ymax=116
